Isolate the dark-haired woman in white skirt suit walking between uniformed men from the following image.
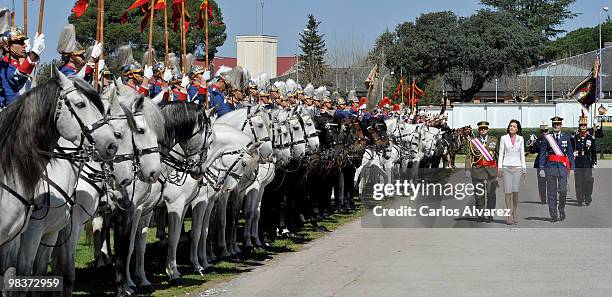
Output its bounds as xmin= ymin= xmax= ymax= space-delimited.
xmin=498 ymin=120 xmax=527 ymax=225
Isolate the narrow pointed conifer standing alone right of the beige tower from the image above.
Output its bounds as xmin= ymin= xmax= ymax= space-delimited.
xmin=300 ymin=14 xmax=327 ymax=85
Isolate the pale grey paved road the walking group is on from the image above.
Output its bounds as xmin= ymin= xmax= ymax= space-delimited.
xmin=199 ymin=163 xmax=612 ymax=297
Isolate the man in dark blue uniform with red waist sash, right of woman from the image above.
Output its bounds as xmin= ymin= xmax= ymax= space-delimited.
xmin=538 ymin=116 xmax=574 ymax=222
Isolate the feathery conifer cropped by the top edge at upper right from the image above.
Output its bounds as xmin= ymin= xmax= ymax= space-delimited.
xmin=480 ymin=0 xmax=578 ymax=41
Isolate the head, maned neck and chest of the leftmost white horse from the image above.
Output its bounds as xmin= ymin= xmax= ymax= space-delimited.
xmin=0 ymin=69 xmax=117 ymax=247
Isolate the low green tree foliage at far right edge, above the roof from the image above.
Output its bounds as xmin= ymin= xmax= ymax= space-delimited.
xmin=546 ymin=20 xmax=612 ymax=60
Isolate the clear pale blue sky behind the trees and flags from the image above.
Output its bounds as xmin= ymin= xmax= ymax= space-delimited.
xmin=0 ymin=0 xmax=612 ymax=63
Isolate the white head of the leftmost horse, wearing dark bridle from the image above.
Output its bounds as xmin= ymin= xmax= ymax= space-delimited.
xmin=52 ymin=67 xmax=118 ymax=160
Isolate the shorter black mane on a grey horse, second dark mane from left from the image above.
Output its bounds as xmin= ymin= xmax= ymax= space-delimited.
xmin=162 ymin=101 xmax=207 ymax=146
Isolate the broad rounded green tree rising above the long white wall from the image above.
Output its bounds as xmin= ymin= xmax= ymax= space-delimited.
xmin=371 ymin=10 xmax=541 ymax=101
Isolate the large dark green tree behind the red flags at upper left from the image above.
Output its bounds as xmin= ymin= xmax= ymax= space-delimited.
xmin=68 ymin=0 xmax=227 ymax=69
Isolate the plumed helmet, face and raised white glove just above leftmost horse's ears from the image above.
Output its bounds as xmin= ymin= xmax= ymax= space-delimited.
xmin=57 ymin=24 xmax=104 ymax=82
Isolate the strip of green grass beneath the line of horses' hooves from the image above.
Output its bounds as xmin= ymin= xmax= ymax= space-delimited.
xmin=74 ymin=201 xmax=364 ymax=297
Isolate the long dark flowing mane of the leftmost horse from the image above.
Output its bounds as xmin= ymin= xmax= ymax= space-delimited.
xmin=0 ymin=80 xmax=61 ymax=196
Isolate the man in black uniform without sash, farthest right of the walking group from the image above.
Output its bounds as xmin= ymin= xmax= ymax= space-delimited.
xmin=573 ymin=116 xmax=597 ymax=206
